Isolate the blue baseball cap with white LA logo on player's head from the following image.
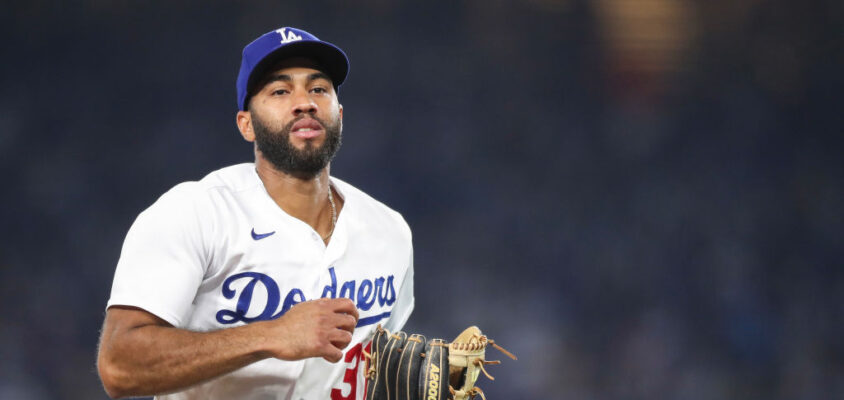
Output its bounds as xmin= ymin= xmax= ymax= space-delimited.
xmin=237 ymin=27 xmax=349 ymax=111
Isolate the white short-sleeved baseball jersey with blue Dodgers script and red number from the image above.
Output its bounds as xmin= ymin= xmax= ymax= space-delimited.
xmin=108 ymin=163 xmax=413 ymax=400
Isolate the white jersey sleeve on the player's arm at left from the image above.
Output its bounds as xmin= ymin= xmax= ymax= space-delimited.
xmin=107 ymin=186 xmax=210 ymax=327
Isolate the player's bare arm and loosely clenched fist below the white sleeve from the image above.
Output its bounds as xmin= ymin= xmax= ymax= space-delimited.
xmin=97 ymin=298 xmax=358 ymax=398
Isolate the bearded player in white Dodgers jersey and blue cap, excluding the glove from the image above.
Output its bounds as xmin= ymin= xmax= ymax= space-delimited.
xmin=97 ymin=28 xmax=413 ymax=400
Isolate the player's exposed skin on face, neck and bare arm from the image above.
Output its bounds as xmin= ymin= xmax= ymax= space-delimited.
xmin=97 ymin=59 xmax=358 ymax=398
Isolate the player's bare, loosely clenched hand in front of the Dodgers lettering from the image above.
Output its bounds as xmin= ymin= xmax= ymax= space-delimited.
xmin=261 ymin=298 xmax=358 ymax=363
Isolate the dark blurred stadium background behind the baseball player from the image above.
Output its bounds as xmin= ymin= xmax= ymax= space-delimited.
xmin=0 ymin=0 xmax=844 ymax=400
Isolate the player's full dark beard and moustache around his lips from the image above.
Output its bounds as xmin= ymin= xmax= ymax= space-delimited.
xmin=252 ymin=111 xmax=343 ymax=180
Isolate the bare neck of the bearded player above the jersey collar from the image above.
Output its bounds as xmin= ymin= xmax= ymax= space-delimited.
xmin=255 ymin=153 xmax=339 ymax=231
